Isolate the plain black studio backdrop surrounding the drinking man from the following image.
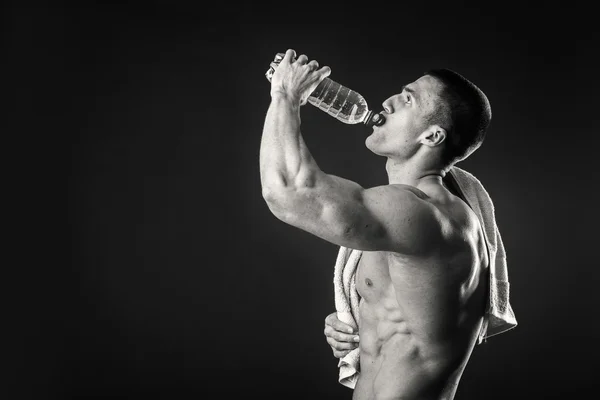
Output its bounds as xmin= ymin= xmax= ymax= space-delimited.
xmin=9 ymin=2 xmax=600 ymax=400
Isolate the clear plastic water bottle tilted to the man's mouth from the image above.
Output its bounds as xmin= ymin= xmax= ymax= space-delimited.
xmin=265 ymin=53 xmax=385 ymax=126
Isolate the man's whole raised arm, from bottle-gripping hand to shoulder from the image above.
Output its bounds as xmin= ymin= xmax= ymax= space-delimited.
xmin=260 ymin=50 xmax=439 ymax=254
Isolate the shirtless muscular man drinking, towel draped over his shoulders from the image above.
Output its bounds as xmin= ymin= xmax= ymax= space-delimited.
xmin=260 ymin=49 xmax=491 ymax=400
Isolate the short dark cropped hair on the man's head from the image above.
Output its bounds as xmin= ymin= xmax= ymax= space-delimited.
xmin=425 ymin=68 xmax=492 ymax=166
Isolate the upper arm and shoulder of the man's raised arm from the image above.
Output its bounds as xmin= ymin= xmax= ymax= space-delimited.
xmin=275 ymin=175 xmax=438 ymax=252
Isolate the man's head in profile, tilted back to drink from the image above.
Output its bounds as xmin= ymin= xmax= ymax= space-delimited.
xmin=366 ymin=69 xmax=491 ymax=167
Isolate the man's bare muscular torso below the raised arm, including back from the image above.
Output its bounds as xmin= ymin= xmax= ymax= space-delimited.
xmin=353 ymin=189 xmax=488 ymax=400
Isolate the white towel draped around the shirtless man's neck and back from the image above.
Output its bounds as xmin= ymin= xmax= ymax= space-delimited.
xmin=333 ymin=166 xmax=517 ymax=389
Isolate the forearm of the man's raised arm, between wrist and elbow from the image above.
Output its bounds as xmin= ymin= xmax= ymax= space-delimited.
xmin=260 ymin=93 xmax=321 ymax=191
